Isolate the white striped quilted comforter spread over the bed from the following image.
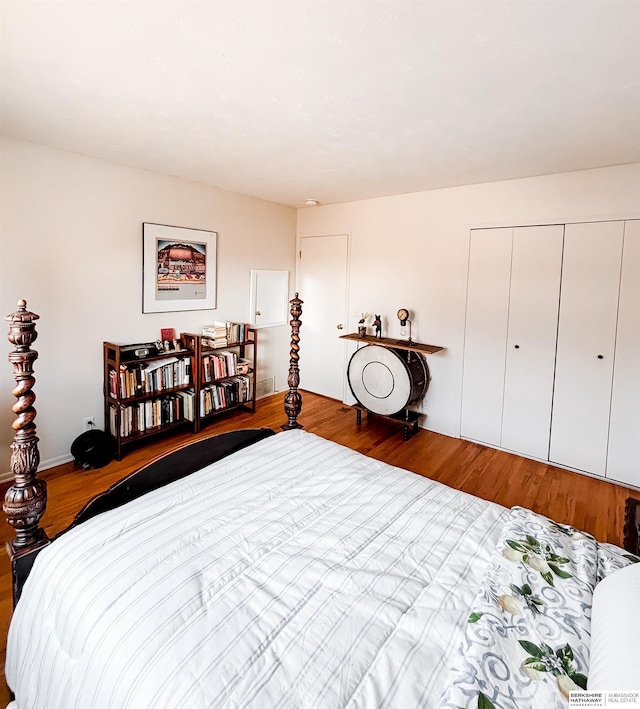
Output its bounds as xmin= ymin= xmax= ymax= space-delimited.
xmin=6 ymin=431 xmax=508 ymax=709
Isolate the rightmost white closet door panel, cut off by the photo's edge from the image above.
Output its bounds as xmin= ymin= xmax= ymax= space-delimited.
xmin=607 ymin=220 xmax=640 ymax=487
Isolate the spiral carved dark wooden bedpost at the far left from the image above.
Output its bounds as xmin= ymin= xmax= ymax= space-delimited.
xmin=3 ymin=300 xmax=48 ymax=560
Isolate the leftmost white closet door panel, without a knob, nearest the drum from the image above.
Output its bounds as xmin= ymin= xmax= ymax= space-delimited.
xmin=461 ymin=229 xmax=513 ymax=446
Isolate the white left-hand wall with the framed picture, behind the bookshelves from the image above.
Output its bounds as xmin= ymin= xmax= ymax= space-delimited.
xmin=0 ymin=138 xmax=296 ymax=474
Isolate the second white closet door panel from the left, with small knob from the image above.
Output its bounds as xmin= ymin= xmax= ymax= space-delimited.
xmin=501 ymin=225 xmax=564 ymax=460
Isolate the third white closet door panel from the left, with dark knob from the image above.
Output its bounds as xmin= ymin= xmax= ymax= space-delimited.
xmin=549 ymin=222 xmax=624 ymax=475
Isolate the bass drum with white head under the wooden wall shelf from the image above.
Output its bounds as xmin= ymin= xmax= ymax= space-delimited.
xmin=347 ymin=345 xmax=429 ymax=416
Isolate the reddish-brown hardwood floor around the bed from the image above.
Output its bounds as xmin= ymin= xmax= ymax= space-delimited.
xmin=0 ymin=393 xmax=640 ymax=706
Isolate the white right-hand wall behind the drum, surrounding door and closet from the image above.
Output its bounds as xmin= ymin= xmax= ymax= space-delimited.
xmin=298 ymin=164 xmax=640 ymax=436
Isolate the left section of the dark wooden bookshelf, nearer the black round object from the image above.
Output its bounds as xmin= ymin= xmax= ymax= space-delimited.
xmin=103 ymin=342 xmax=196 ymax=460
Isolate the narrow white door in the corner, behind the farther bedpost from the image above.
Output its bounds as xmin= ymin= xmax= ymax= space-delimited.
xmin=298 ymin=234 xmax=347 ymax=401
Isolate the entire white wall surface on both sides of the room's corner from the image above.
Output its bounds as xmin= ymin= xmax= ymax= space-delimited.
xmin=0 ymin=138 xmax=640 ymax=473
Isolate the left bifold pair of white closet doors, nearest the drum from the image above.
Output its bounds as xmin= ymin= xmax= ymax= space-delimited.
xmin=461 ymin=225 xmax=563 ymax=460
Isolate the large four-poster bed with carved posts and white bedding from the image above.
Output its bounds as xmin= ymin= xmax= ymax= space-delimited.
xmin=5 ymin=295 xmax=640 ymax=709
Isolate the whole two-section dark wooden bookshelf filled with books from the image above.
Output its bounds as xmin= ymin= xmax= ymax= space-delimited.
xmin=103 ymin=326 xmax=257 ymax=460
